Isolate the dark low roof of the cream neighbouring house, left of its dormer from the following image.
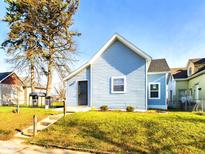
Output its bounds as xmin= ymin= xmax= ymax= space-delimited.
xmin=171 ymin=68 xmax=188 ymax=79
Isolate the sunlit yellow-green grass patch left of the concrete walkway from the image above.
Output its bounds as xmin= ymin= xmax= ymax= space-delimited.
xmin=0 ymin=107 xmax=55 ymax=140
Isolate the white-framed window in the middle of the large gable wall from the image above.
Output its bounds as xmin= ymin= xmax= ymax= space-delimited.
xmin=111 ymin=76 xmax=126 ymax=93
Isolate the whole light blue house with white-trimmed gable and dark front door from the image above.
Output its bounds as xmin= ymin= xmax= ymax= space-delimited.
xmin=64 ymin=34 xmax=172 ymax=111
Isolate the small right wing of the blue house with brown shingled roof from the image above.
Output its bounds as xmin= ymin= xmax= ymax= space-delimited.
xmin=148 ymin=59 xmax=174 ymax=109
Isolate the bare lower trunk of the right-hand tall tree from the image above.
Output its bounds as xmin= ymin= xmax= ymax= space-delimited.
xmin=46 ymin=61 xmax=53 ymax=96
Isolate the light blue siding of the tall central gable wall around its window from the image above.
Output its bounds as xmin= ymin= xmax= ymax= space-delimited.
xmin=92 ymin=41 xmax=146 ymax=110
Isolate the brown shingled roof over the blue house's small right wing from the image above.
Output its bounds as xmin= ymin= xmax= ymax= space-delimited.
xmin=148 ymin=59 xmax=170 ymax=72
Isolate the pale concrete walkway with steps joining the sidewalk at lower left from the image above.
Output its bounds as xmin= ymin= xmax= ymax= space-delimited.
xmin=0 ymin=113 xmax=88 ymax=154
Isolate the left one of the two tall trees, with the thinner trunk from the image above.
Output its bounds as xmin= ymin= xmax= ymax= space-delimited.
xmin=2 ymin=0 xmax=42 ymax=91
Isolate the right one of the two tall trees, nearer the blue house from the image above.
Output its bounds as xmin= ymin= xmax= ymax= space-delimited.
xmin=32 ymin=0 xmax=79 ymax=96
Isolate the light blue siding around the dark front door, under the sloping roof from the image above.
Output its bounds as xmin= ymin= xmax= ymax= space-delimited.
xmin=66 ymin=67 xmax=90 ymax=107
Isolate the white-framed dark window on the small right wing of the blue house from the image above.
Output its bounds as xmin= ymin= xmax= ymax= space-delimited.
xmin=149 ymin=83 xmax=160 ymax=99
